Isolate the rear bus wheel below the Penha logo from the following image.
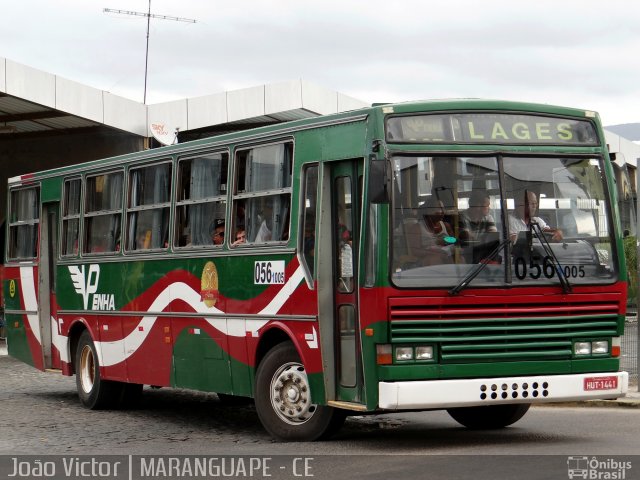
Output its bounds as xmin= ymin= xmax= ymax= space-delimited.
xmin=75 ymin=330 xmax=125 ymax=410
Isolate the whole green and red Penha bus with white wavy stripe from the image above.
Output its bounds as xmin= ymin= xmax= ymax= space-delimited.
xmin=4 ymin=100 xmax=628 ymax=440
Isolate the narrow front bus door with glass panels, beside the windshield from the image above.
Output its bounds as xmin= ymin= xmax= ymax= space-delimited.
xmin=331 ymin=160 xmax=363 ymax=403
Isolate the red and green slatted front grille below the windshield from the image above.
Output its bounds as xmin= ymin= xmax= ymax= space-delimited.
xmin=389 ymin=298 xmax=619 ymax=363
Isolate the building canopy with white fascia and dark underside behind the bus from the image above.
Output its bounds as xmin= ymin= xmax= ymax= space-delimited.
xmin=0 ymin=57 xmax=368 ymax=219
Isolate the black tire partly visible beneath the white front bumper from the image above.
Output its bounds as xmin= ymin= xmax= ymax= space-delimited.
xmin=447 ymin=403 xmax=531 ymax=430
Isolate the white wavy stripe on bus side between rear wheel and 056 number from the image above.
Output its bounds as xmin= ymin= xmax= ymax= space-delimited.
xmin=95 ymin=266 xmax=304 ymax=367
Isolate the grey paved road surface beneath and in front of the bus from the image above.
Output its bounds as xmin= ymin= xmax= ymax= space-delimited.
xmin=0 ymin=356 xmax=640 ymax=480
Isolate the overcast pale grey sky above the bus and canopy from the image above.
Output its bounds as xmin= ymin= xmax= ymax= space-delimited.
xmin=0 ymin=0 xmax=640 ymax=125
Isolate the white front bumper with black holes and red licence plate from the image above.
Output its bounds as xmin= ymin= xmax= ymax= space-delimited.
xmin=378 ymin=372 xmax=629 ymax=410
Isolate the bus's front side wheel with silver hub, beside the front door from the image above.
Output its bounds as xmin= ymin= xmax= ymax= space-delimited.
xmin=255 ymin=342 xmax=346 ymax=442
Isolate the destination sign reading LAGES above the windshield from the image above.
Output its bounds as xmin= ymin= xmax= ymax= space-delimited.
xmin=386 ymin=113 xmax=598 ymax=146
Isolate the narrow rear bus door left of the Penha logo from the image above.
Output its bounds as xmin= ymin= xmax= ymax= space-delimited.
xmin=38 ymin=203 xmax=60 ymax=369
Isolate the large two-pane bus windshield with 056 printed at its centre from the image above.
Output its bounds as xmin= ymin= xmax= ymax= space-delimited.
xmin=391 ymin=155 xmax=616 ymax=288
